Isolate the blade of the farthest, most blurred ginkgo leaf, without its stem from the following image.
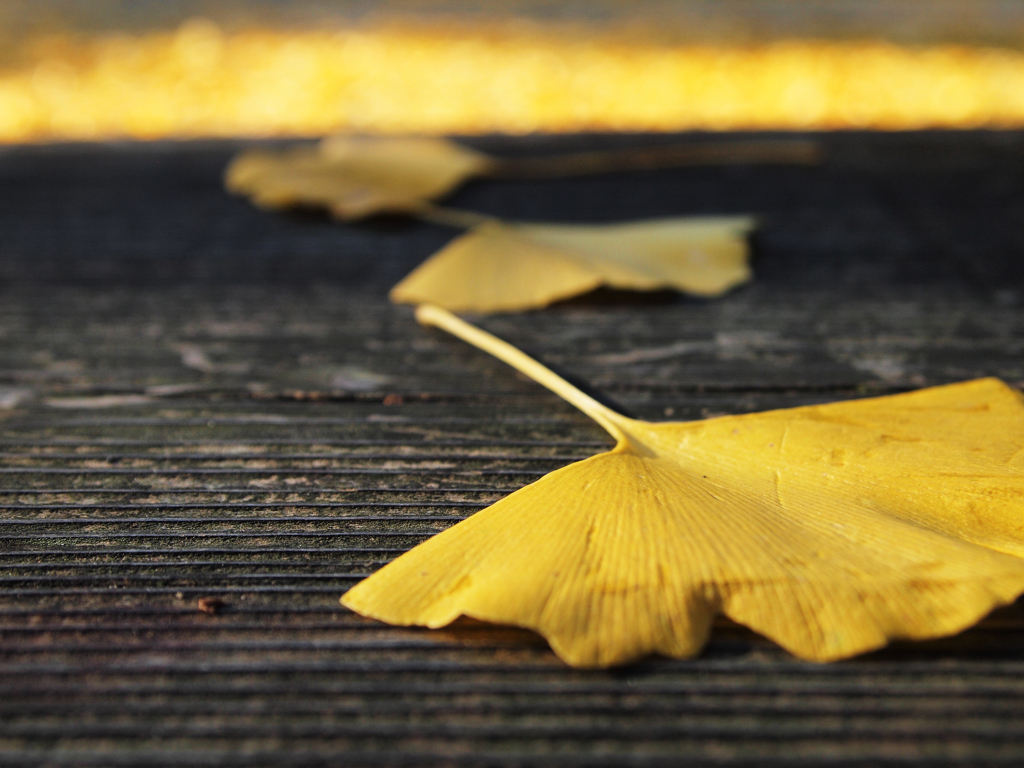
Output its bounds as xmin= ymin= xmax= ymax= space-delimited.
xmin=225 ymin=136 xmax=492 ymax=219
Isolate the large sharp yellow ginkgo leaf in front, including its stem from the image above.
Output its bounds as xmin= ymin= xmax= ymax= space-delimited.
xmin=342 ymin=307 xmax=1024 ymax=667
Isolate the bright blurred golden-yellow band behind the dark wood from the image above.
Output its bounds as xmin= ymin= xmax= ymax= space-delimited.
xmin=6 ymin=2 xmax=1024 ymax=142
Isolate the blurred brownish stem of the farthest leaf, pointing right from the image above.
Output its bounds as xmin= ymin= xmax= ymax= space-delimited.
xmin=483 ymin=139 xmax=821 ymax=179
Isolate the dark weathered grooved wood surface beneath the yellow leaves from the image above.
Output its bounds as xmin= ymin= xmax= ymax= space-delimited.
xmin=0 ymin=133 xmax=1024 ymax=766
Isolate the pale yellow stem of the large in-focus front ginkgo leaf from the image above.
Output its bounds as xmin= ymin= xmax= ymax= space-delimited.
xmin=416 ymin=304 xmax=629 ymax=443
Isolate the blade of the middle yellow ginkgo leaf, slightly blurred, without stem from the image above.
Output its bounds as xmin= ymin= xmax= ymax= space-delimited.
xmin=391 ymin=216 xmax=755 ymax=312
